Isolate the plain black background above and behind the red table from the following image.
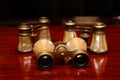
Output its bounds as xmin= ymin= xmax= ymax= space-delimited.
xmin=0 ymin=0 xmax=120 ymax=19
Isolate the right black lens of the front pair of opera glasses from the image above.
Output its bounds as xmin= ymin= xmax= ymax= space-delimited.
xmin=73 ymin=53 xmax=89 ymax=68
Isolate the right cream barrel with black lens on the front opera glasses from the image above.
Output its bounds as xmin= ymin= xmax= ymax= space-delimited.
xmin=66 ymin=37 xmax=89 ymax=68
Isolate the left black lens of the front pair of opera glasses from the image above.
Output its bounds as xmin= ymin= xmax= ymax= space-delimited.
xmin=38 ymin=55 xmax=54 ymax=69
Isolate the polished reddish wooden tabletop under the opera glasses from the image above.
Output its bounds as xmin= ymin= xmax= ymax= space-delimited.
xmin=0 ymin=25 xmax=120 ymax=80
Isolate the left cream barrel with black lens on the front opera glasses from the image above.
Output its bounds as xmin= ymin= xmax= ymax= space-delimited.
xmin=33 ymin=39 xmax=54 ymax=69
